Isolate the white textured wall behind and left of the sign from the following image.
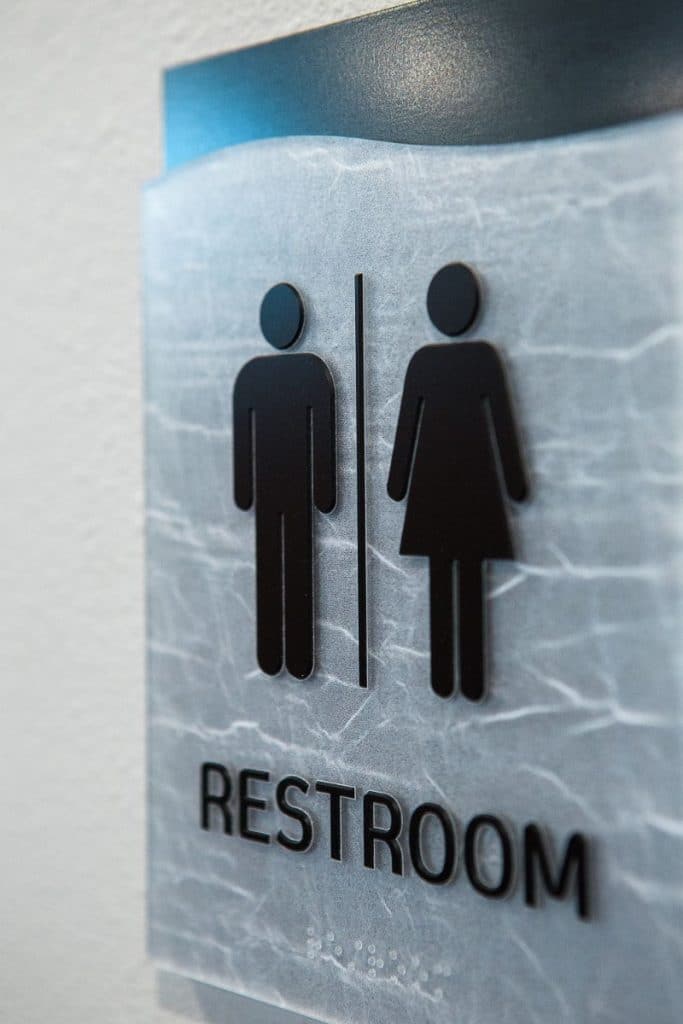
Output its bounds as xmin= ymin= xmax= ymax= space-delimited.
xmin=0 ymin=0 xmax=390 ymax=1024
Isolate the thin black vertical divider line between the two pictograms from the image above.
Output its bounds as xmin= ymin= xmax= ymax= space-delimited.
xmin=354 ymin=273 xmax=368 ymax=687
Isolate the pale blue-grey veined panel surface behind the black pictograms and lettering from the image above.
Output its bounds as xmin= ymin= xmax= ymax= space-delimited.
xmin=144 ymin=116 xmax=683 ymax=1024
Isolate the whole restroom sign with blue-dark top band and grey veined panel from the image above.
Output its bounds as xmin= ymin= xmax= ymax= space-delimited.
xmin=143 ymin=0 xmax=683 ymax=1024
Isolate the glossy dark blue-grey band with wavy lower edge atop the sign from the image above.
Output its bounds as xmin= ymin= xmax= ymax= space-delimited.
xmin=165 ymin=0 xmax=683 ymax=169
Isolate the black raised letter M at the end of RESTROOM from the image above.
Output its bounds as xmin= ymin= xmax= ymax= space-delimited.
xmin=524 ymin=824 xmax=590 ymax=921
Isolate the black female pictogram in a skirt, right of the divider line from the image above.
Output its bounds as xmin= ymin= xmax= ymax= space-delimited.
xmin=388 ymin=263 xmax=527 ymax=700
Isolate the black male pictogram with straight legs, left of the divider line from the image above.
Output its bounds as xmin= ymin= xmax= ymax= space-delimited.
xmin=232 ymin=284 xmax=336 ymax=679
